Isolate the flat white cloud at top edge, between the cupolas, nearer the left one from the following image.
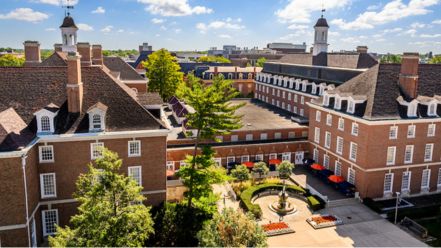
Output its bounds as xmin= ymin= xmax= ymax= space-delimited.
xmin=138 ymin=0 xmax=213 ymax=16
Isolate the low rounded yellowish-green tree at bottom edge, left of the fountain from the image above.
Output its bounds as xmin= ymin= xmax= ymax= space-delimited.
xmin=198 ymin=208 xmax=267 ymax=247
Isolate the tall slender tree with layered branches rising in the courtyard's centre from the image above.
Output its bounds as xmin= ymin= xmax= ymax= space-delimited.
xmin=178 ymin=74 xmax=243 ymax=208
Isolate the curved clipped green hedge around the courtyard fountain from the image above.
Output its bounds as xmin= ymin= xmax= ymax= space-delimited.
xmin=240 ymin=184 xmax=325 ymax=218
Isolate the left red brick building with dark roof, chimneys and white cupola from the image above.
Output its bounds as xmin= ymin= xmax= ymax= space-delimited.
xmin=0 ymin=16 xmax=169 ymax=246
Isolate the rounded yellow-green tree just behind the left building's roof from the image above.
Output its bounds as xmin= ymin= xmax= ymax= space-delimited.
xmin=143 ymin=49 xmax=184 ymax=101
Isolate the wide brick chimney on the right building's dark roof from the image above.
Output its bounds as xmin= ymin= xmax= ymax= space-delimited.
xmin=399 ymin=53 xmax=420 ymax=98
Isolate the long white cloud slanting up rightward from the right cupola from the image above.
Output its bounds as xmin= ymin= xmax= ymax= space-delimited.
xmin=331 ymin=0 xmax=440 ymax=30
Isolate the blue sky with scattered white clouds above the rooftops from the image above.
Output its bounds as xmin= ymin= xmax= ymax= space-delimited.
xmin=0 ymin=0 xmax=441 ymax=53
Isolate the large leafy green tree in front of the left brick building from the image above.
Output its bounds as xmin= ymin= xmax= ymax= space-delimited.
xmin=49 ymin=149 xmax=153 ymax=247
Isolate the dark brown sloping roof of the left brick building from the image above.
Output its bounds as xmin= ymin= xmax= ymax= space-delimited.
xmin=0 ymin=66 xmax=164 ymax=150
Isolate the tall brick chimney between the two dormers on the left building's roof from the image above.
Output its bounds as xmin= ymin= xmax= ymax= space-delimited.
xmin=66 ymin=52 xmax=83 ymax=113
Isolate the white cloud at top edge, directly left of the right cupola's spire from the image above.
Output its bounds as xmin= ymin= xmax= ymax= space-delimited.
xmin=275 ymin=0 xmax=351 ymax=23
